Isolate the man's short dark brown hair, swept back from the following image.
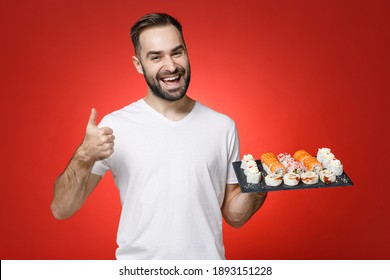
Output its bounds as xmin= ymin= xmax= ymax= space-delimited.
xmin=130 ymin=13 xmax=184 ymax=54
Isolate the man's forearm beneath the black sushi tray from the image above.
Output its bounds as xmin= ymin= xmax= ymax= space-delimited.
xmin=223 ymin=188 xmax=267 ymax=228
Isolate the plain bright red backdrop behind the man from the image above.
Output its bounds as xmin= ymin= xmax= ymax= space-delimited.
xmin=0 ymin=0 xmax=390 ymax=259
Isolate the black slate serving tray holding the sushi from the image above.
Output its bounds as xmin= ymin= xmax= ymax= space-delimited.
xmin=233 ymin=160 xmax=353 ymax=193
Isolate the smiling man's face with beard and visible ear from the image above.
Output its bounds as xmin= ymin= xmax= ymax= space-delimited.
xmin=133 ymin=25 xmax=191 ymax=101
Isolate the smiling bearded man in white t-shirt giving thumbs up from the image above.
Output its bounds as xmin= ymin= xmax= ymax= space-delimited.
xmin=51 ymin=14 xmax=266 ymax=259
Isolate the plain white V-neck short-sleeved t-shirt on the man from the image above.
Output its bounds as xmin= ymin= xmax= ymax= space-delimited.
xmin=92 ymin=99 xmax=240 ymax=259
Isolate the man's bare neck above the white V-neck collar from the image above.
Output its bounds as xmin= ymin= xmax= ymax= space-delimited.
xmin=144 ymin=93 xmax=195 ymax=121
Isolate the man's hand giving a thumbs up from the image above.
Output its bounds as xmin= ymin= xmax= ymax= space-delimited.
xmin=79 ymin=108 xmax=115 ymax=163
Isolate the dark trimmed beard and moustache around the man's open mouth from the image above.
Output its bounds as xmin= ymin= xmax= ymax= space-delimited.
xmin=142 ymin=65 xmax=191 ymax=101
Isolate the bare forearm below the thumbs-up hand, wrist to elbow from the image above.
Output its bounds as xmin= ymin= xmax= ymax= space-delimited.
xmin=50 ymin=146 xmax=94 ymax=219
